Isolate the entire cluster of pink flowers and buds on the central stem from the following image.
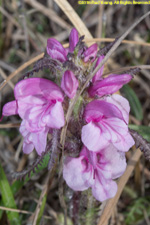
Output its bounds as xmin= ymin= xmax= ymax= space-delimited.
xmin=3 ymin=29 xmax=134 ymax=201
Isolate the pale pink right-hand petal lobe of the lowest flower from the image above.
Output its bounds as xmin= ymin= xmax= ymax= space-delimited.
xmin=99 ymin=144 xmax=127 ymax=179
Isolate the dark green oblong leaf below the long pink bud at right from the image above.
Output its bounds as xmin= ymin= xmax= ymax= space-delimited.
xmin=122 ymin=84 xmax=143 ymax=120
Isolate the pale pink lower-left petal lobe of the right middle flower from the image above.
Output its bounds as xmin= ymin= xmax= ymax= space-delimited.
xmin=81 ymin=122 xmax=109 ymax=152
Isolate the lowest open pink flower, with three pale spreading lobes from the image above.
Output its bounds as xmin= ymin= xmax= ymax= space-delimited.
xmin=63 ymin=145 xmax=126 ymax=201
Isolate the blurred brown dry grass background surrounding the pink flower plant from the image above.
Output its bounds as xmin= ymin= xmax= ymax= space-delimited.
xmin=0 ymin=0 xmax=150 ymax=225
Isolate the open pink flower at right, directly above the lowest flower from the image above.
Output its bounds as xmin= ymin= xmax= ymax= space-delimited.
xmin=82 ymin=95 xmax=134 ymax=152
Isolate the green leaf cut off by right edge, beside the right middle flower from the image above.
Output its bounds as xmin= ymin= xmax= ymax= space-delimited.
xmin=129 ymin=124 xmax=150 ymax=141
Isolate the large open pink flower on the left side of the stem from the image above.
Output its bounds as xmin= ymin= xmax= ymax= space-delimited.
xmin=3 ymin=78 xmax=64 ymax=155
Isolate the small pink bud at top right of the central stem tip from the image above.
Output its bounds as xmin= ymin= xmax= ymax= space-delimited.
xmin=84 ymin=44 xmax=97 ymax=63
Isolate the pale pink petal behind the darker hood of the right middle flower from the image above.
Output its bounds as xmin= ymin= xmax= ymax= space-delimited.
xmin=106 ymin=94 xmax=130 ymax=124
